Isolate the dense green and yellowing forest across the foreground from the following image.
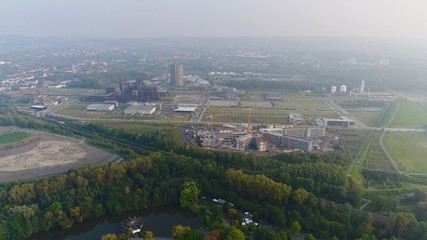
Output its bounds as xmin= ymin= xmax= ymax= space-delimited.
xmin=0 ymin=109 xmax=427 ymax=240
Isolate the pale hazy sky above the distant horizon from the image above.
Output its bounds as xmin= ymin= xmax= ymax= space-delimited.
xmin=0 ymin=0 xmax=427 ymax=39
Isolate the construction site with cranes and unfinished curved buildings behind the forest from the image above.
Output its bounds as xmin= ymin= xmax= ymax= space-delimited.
xmin=190 ymin=109 xmax=328 ymax=152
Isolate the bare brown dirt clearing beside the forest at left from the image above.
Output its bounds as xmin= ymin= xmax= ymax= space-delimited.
xmin=0 ymin=129 xmax=120 ymax=182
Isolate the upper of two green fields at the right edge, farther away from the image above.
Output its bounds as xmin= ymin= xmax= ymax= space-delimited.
xmin=391 ymin=100 xmax=427 ymax=128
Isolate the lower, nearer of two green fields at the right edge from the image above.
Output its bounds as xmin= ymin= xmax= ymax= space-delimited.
xmin=384 ymin=132 xmax=427 ymax=174
